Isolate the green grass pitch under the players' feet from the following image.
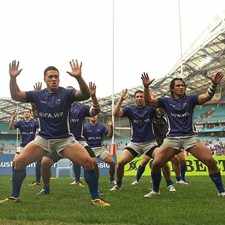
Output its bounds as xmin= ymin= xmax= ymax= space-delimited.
xmin=0 ymin=176 xmax=225 ymax=225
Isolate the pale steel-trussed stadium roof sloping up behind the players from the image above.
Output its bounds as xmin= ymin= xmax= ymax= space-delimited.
xmin=0 ymin=17 xmax=225 ymax=121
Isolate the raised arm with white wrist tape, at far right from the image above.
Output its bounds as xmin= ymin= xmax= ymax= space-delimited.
xmin=198 ymin=72 xmax=223 ymax=105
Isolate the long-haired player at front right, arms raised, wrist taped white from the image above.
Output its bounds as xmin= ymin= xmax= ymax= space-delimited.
xmin=143 ymin=72 xmax=225 ymax=197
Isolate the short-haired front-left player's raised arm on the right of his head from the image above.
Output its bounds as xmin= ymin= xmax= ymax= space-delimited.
xmin=67 ymin=60 xmax=90 ymax=101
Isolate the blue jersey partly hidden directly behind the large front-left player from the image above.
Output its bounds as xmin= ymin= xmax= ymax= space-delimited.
xmin=69 ymin=102 xmax=96 ymax=141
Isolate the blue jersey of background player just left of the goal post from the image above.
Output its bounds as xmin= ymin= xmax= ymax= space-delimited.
xmin=83 ymin=123 xmax=108 ymax=148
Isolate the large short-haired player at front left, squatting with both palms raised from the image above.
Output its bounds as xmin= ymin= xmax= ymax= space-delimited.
xmin=1 ymin=60 xmax=108 ymax=206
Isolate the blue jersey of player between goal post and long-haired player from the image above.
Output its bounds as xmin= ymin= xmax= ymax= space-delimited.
xmin=123 ymin=105 xmax=155 ymax=143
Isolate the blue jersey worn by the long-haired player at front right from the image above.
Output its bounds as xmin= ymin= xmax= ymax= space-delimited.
xmin=159 ymin=95 xmax=198 ymax=137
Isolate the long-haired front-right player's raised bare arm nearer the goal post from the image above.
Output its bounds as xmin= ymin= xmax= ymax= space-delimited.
xmin=141 ymin=73 xmax=158 ymax=106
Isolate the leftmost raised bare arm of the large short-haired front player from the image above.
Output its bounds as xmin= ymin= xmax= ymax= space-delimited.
xmin=9 ymin=60 xmax=26 ymax=102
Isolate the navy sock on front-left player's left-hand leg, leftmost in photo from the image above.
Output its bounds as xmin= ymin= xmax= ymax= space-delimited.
xmin=11 ymin=167 xmax=26 ymax=198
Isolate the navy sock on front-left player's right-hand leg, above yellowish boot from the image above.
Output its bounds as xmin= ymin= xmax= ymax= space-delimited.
xmin=84 ymin=169 xmax=99 ymax=199
